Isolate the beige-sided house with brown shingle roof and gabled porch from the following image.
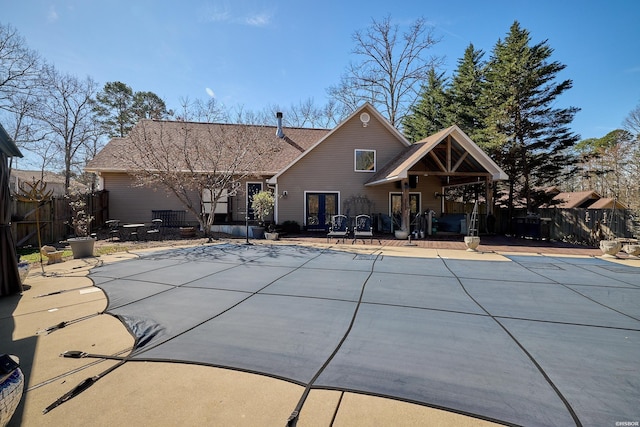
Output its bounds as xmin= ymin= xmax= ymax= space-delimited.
xmin=86 ymin=103 xmax=507 ymax=236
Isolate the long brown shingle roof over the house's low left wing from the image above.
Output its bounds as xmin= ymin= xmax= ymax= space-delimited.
xmin=85 ymin=120 xmax=329 ymax=175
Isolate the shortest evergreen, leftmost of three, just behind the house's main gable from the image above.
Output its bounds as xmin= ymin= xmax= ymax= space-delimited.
xmin=402 ymin=68 xmax=449 ymax=142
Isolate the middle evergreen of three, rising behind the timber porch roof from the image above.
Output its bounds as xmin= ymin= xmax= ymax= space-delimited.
xmin=447 ymin=44 xmax=485 ymax=144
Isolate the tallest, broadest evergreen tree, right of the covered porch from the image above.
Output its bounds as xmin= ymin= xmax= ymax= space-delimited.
xmin=480 ymin=21 xmax=579 ymax=213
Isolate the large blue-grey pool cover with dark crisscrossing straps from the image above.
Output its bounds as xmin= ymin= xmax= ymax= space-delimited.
xmin=90 ymin=244 xmax=640 ymax=426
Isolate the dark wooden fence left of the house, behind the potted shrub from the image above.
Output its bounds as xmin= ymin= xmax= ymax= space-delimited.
xmin=11 ymin=191 xmax=109 ymax=247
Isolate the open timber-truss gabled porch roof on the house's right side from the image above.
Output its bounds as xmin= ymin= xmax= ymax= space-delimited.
xmin=365 ymin=125 xmax=508 ymax=186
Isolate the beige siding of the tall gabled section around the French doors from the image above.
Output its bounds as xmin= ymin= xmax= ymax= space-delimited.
xmin=277 ymin=110 xmax=440 ymax=225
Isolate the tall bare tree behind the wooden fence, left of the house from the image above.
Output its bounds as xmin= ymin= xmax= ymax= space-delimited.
xmin=38 ymin=66 xmax=98 ymax=189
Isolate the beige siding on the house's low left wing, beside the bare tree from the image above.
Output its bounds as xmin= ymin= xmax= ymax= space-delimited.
xmin=102 ymin=173 xmax=197 ymax=223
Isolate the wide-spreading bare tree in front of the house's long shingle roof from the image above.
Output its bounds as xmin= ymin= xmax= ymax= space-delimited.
xmin=119 ymin=112 xmax=277 ymax=239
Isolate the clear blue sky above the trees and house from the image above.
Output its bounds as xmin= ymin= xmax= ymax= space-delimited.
xmin=5 ymin=0 xmax=640 ymax=138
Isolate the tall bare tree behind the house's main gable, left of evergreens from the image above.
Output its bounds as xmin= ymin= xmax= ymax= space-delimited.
xmin=328 ymin=16 xmax=441 ymax=126
